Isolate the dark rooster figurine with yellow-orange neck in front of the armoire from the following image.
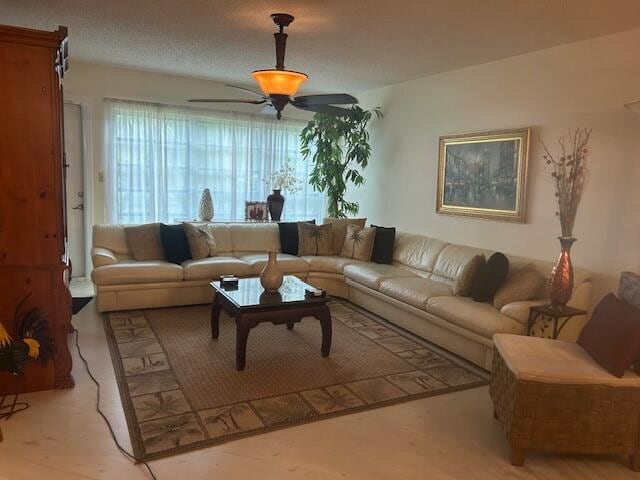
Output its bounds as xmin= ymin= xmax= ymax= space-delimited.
xmin=0 ymin=294 xmax=54 ymax=375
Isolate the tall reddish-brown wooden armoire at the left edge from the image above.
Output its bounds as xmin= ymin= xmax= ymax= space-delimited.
xmin=0 ymin=26 xmax=73 ymax=395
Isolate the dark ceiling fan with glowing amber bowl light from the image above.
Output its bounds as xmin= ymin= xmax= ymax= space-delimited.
xmin=189 ymin=13 xmax=358 ymax=120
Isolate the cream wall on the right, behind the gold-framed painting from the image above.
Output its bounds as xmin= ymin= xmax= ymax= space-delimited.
xmin=351 ymin=29 xmax=640 ymax=308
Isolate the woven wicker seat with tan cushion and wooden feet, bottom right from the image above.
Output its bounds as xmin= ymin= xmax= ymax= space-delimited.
xmin=489 ymin=334 xmax=640 ymax=471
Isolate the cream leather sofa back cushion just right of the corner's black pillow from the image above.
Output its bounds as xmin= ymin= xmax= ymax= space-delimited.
xmin=393 ymin=232 xmax=447 ymax=277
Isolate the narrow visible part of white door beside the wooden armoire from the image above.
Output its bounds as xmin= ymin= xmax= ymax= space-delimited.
xmin=64 ymin=103 xmax=86 ymax=279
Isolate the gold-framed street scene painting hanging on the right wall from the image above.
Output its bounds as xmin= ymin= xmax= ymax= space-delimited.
xmin=436 ymin=128 xmax=530 ymax=222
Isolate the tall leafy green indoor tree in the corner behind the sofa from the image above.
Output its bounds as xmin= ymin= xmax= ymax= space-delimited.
xmin=300 ymin=105 xmax=382 ymax=218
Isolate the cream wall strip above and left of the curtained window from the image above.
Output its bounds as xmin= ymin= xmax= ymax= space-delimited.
xmin=64 ymin=62 xmax=309 ymax=224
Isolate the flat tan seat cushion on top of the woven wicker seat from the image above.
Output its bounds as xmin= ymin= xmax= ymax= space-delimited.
xmin=493 ymin=334 xmax=640 ymax=387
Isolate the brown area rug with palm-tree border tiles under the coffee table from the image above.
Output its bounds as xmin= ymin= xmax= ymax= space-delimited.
xmin=105 ymin=301 xmax=487 ymax=460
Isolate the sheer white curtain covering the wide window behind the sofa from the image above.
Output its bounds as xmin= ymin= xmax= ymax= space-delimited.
xmin=105 ymin=99 xmax=324 ymax=224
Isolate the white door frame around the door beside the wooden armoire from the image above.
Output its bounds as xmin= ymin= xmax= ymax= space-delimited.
xmin=64 ymin=94 xmax=93 ymax=280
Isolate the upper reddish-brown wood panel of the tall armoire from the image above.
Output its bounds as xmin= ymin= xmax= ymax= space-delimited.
xmin=0 ymin=43 xmax=64 ymax=266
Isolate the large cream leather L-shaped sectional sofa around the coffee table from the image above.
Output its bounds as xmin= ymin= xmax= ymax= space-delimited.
xmin=91 ymin=223 xmax=591 ymax=369
